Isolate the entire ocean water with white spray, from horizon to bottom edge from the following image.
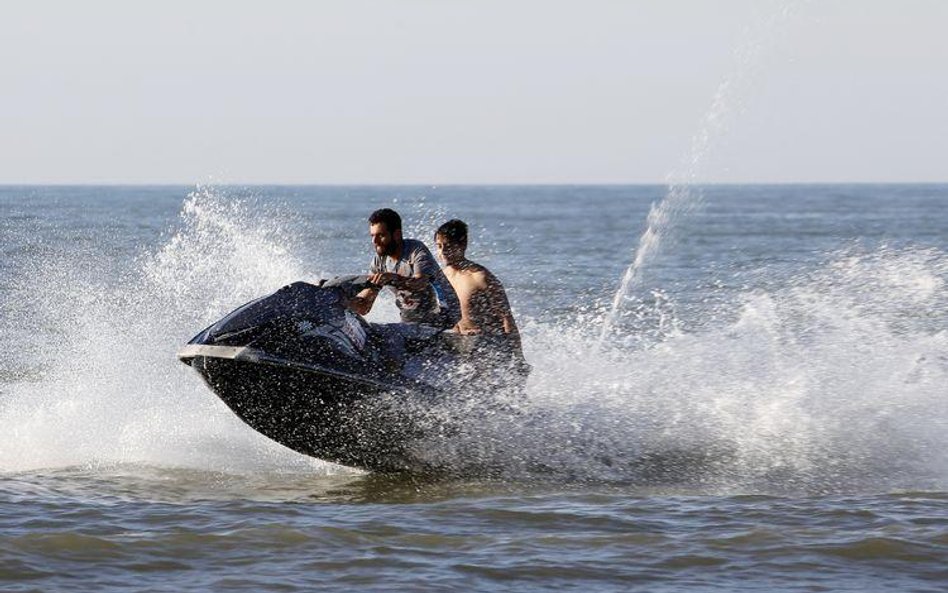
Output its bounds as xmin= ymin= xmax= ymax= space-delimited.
xmin=0 ymin=185 xmax=948 ymax=592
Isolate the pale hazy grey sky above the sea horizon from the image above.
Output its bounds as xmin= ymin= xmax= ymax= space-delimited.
xmin=0 ymin=0 xmax=948 ymax=184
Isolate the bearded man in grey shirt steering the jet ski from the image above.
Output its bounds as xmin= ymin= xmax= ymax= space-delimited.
xmin=349 ymin=208 xmax=461 ymax=329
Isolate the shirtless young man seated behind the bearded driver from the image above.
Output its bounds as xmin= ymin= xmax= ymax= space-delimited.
xmin=435 ymin=219 xmax=523 ymax=359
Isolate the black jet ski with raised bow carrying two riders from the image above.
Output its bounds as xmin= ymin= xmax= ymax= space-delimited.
xmin=178 ymin=276 xmax=529 ymax=473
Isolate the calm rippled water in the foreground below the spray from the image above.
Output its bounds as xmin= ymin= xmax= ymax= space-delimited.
xmin=0 ymin=467 xmax=948 ymax=591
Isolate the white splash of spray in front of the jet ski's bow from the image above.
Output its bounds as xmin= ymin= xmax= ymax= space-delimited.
xmin=0 ymin=187 xmax=348 ymax=472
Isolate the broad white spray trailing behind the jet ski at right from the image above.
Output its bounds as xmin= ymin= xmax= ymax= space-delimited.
xmin=426 ymin=246 xmax=948 ymax=494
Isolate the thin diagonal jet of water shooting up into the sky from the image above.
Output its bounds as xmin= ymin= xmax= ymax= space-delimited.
xmin=599 ymin=0 xmax=801 ymax=349
